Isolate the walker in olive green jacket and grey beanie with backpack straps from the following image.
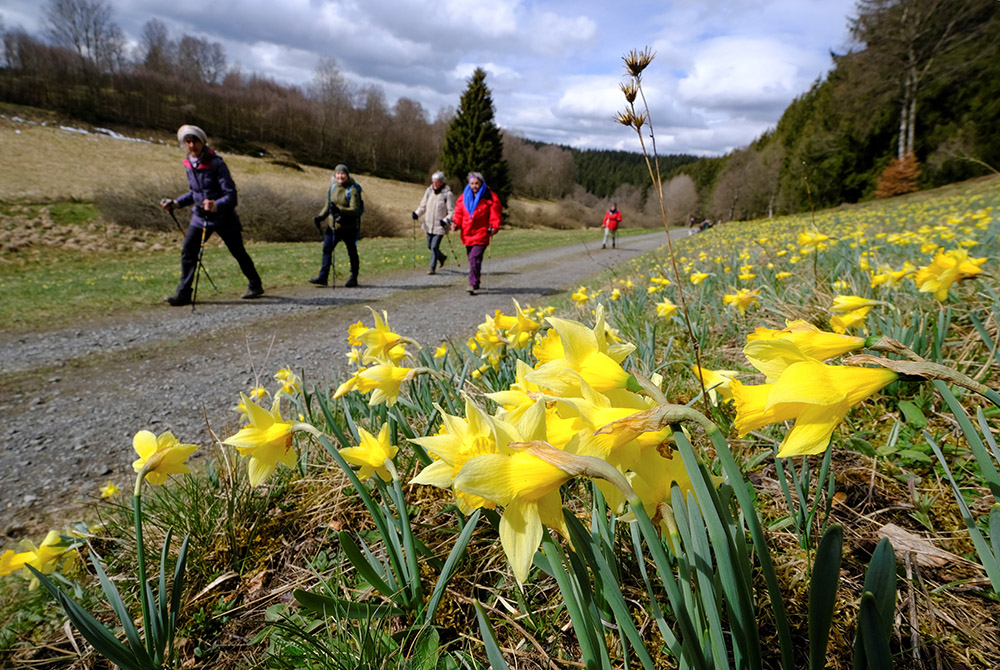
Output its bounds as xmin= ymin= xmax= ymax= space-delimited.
xmin=309 ymin=164 xmax=364 ymax=288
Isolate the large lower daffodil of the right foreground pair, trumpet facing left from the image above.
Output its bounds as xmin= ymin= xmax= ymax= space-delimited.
xmin=731 ymin=358 xmax=898 ymax=458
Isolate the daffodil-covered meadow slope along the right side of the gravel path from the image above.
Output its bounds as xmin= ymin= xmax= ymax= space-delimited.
xmin=0 ymin=113 xmax=1000 ymax=670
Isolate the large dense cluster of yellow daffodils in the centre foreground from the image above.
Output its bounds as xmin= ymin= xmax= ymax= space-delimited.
xmin=411 ymin=306 xmax=690 ymax=582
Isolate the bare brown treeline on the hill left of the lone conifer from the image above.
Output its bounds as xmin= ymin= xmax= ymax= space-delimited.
xmin=0 ymin=19 xmax=447 ymax=179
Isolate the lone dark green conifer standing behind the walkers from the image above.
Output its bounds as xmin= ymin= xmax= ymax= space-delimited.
xmin=441 ymin=68 xmax=511 ymax=205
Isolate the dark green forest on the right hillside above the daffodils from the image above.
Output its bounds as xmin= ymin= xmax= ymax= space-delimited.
xmin=675 ymin=0 xmax=1000 ymax=219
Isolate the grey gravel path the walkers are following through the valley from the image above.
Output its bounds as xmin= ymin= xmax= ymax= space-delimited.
xmin=0 ymin=233 xmax=683 ymax=544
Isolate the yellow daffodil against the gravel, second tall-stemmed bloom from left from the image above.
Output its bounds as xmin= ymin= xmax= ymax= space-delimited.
xmin=222 ymin=396 xmax=298 ymax=486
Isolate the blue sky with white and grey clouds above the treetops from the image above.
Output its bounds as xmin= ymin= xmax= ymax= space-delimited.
xmin=0 ymin=0 xmax=856 ymax=155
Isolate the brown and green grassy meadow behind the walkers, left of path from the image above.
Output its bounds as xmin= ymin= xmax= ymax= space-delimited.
xmin=0 ymin=120 xmax=647 ymax=333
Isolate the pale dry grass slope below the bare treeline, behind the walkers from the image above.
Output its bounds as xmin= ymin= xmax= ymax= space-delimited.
xmin=0 ymin=118 xmax=603 ymax=235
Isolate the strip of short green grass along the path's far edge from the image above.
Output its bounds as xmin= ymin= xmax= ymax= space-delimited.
xmin=0 ymin=226 xmax=650 ymax=332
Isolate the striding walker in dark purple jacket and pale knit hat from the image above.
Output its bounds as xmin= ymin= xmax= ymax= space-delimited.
xmin=160 ymin=125 xmax=264 ymax=307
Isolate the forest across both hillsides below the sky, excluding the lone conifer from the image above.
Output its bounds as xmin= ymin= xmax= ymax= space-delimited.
xmin=0 ymin=0 xmax=1000 ymax=223
